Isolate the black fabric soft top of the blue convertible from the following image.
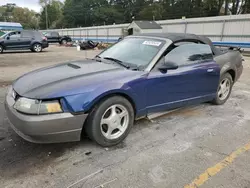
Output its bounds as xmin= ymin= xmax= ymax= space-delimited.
xmin=135 ymin=33 xmax=221 ymax=55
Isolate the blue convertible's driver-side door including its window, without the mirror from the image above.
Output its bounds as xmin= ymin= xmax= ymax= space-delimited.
xmin=146 ymin=43 xmax=220 ymax=112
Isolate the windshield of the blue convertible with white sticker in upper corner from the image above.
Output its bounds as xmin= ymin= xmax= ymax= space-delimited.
xmin=98 ymin=38 xmax=165 ymax=67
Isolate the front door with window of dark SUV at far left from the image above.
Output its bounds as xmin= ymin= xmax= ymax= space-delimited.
xmin=4 ymin=31 xmax=21 ymax=50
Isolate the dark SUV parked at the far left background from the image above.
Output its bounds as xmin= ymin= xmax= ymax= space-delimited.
xmin=0 ymin=30 xmax=49 ymax=53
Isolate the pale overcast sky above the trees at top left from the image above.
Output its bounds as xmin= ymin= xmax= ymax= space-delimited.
xmin=0 ymin=0 xmax=63 ymax=12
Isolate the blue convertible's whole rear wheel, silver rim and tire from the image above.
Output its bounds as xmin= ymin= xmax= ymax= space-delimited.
xmin=212 ymin=73 xmax=233 ymax=105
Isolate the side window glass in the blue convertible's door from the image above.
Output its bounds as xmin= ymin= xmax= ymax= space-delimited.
xmin=165 ymin=44 xmax=213 ymax=66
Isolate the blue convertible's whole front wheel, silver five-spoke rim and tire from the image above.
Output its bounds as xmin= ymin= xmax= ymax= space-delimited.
xmin=85 ymin=96 xmax=134 ymax=147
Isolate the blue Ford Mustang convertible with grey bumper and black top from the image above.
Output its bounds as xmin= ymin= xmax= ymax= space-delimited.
xmin=5 ymin=33 xmax=243 ymax=146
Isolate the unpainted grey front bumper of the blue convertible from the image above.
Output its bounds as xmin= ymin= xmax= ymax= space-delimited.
xmin=5 ymin=89 xmax=87 ymax=143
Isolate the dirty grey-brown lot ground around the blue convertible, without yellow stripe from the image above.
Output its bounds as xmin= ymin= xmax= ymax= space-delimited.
xmin=0 ymin=47 xmax=250 ymax=188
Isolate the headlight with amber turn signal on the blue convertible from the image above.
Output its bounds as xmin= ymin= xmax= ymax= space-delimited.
xmin=14 ymin=97 xmax=63 ymax=115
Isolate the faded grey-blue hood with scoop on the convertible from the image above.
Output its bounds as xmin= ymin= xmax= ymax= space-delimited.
xmin=13 ymin=60 xmax=143 ymax=99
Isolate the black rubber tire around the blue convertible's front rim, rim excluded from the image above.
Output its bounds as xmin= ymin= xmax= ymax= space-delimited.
xmin=85 ymin=96 xmax=134 ymax=147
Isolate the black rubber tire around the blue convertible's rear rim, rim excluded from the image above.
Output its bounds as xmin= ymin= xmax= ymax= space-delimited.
xmin=212 ymin=73 xmax=233 ymax=105
